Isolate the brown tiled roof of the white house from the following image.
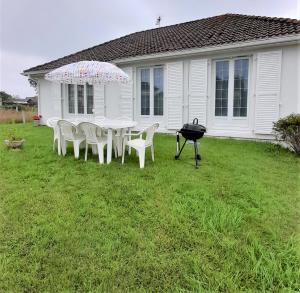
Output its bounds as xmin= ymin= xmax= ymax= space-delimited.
xmin=24 ymin=14 xmax=300 ymax=72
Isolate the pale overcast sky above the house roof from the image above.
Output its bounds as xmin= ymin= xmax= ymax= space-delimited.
xmin=0 ymin=0 xmax=300 ymax=98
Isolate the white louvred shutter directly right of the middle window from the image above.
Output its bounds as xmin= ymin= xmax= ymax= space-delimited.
xmin=166 ymin=62 xmax=183 ymax=129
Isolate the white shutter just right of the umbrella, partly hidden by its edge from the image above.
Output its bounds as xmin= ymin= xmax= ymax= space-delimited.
xmin=120 ymin=67 xmax=133 ymax=119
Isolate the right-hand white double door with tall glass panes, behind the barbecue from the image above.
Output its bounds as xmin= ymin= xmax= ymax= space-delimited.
xmin=211 ymin=57 xmax=250 ymax=131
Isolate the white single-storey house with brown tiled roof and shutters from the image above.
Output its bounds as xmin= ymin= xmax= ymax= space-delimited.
xmin=23 ymin=14 xmax=300 ymax=138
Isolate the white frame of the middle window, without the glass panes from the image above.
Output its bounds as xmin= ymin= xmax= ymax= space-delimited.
xmin=137 ymin=64 xmax=166 ymax=119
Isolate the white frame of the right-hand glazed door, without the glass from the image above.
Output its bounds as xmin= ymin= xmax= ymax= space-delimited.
xmin=212 ymin=56 xmax=252 ymax=121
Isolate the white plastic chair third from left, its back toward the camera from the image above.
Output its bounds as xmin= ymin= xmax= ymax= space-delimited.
xmin=78 ymin=122 xmax=107 ymax=164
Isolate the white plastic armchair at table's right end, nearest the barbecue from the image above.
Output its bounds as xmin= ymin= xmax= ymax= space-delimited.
xmin=122 ymin=123 xmax=159 ymax=168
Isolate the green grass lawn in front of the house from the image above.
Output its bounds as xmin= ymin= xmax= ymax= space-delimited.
xmin=0 ymin=125 xmax=300 ymax=292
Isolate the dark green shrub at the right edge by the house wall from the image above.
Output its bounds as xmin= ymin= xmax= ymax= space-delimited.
xmin=273 ymin=114 xmax=300 ymax=155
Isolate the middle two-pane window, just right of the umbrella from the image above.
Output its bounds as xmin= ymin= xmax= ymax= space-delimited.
xmin=140 ymin=66 xmax=164 ymax=116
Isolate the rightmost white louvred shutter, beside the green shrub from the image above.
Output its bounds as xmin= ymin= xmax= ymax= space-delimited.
xmin=255 ymin=50 xmax=282 ymax=134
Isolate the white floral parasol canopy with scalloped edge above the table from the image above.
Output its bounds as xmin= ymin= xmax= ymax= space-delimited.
xmin=45 ymin=61 xmax=129 ymax=84
